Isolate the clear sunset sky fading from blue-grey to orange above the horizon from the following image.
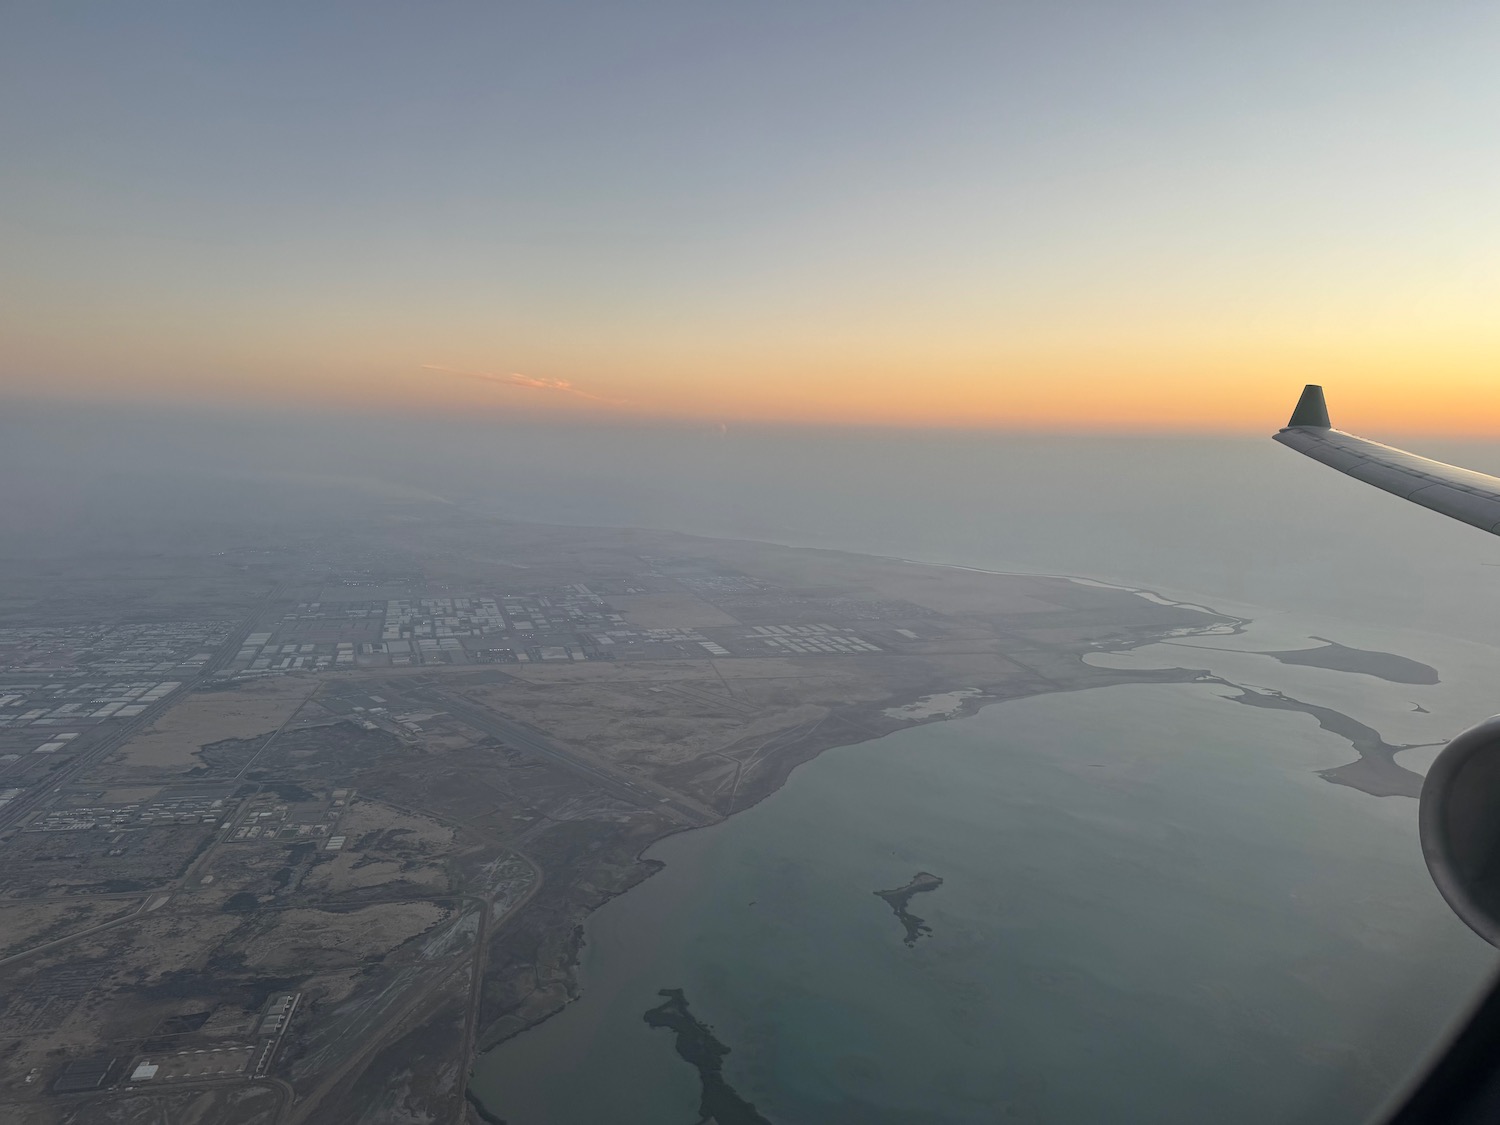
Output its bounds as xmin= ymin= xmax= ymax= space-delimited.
xmin=0 ymin=0 xmax=1500 ymax=435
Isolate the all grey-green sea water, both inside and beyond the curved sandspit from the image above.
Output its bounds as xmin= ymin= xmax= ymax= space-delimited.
xmin=474 ymin=435 xmax=1500 ymax=1125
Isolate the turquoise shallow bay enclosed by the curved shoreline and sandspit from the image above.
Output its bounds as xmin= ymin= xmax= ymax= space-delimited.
xmin=476 ymin=674 xmax=1491 ymax=1125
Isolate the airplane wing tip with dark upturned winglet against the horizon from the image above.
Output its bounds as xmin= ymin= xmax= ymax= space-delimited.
xmin=1275 ymin=384 xmax=1500 ymax=536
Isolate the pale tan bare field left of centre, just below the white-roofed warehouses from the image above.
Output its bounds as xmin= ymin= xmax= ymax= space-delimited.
xmin=110 ymin=677 xmax=318 ymax=773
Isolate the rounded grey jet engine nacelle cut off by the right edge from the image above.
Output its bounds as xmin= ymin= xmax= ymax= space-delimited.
xmin=1418 ymin=716 xmax=1500 ymax=947
